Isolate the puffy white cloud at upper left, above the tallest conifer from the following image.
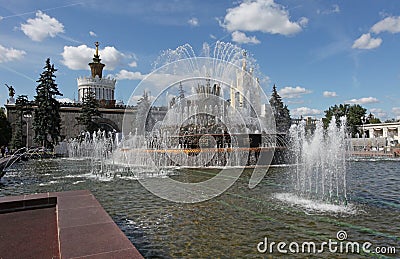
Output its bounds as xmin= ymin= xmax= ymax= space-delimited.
xmin=21 ymin=11 xmax=64 ymax=41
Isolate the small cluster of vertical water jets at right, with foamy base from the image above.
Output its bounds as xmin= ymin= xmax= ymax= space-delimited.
xmin=275 ymin=117 xmax=352 ymax=212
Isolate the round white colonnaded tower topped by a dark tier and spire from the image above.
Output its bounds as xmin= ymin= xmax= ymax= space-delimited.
xmin=77 ymin=42 xmax=117 ymax=107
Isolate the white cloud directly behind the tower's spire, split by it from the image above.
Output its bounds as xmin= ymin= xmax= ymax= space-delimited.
xmin=61 ymin=45 xmax=126 ymax=70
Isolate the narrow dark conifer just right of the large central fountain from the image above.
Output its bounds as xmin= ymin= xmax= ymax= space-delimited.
xmin=269 ymin=85 xmax=291 ymax=133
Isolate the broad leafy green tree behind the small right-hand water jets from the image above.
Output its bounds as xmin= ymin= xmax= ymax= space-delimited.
xmin=322 ymin=104 xmax=367 ymax=136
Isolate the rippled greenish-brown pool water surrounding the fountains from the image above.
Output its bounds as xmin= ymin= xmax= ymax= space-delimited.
xmin=0 ymin=159 xmax=400 ymax=258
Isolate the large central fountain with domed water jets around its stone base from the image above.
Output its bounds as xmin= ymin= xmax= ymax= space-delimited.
xmin=114 ymin=42 xmax=275 ymax=170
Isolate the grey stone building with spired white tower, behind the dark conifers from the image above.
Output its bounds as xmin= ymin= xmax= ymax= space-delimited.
xmin=5 ymin=42 xmax=166 ymax=147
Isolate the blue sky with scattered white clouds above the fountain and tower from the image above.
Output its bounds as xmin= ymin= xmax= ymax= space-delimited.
xmin=0 ymin=0 xmax=400 ymax=120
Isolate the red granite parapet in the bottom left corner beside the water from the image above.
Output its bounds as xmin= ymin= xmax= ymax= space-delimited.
xmin=0 ymin=190 xmax=143 ymax=258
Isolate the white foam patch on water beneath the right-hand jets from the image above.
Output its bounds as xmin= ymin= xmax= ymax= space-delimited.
xmin=273 ymin=193 xmax=357 ymax=214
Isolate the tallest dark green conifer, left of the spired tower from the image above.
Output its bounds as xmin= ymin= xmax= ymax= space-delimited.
xmin=33 ymin=58 xmax=62 ymax=148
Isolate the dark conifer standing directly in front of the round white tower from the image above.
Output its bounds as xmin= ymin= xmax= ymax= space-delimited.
xmin=76 ymin=91 xmax=102 ymax=133
